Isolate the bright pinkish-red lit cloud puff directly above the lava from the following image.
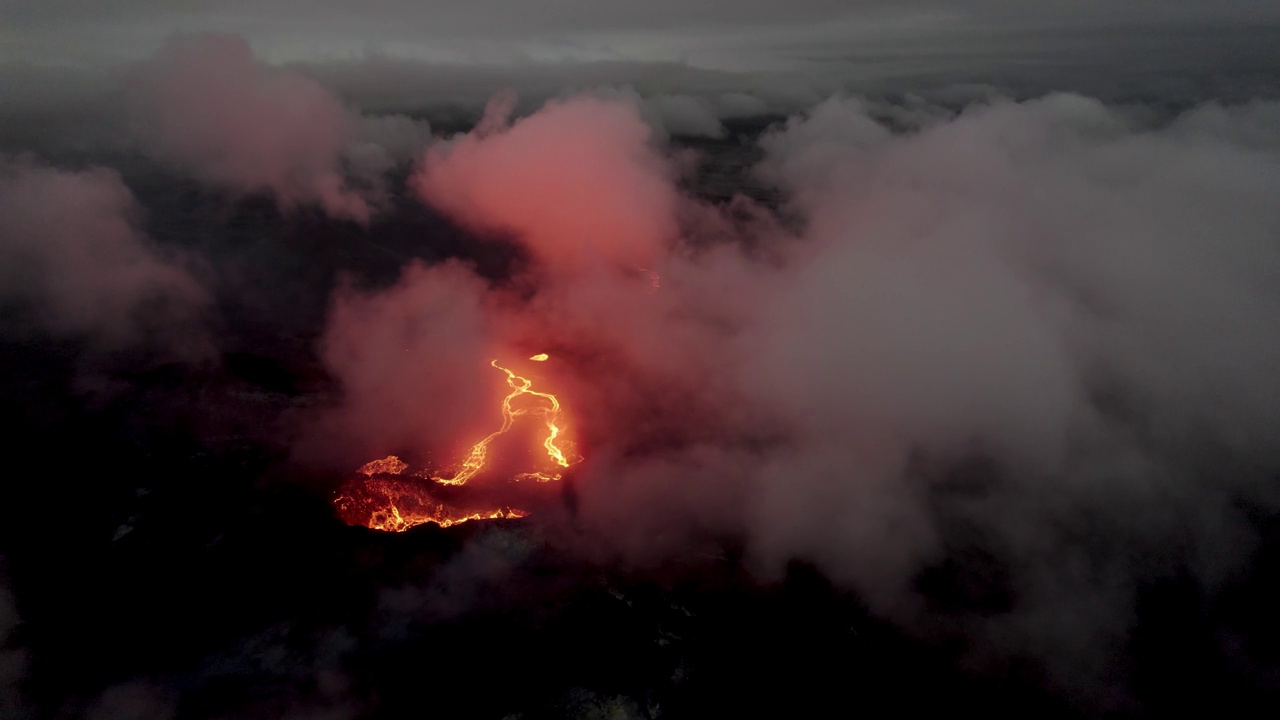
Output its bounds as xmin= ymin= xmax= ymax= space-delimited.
xmin=413 ymin=97 xmax=678 ymax=273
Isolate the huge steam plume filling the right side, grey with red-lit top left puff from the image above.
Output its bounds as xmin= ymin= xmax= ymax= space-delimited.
xmin=312 ymin=89 xmax=1280 ymax=702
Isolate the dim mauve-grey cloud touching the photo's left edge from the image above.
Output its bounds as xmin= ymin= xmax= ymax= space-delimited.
xmin=0 ymin=159 xmax=212 ymax=360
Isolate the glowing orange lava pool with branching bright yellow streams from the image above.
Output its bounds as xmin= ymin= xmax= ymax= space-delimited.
xmin=333 ymin=354 xmax=577 ymax=532
